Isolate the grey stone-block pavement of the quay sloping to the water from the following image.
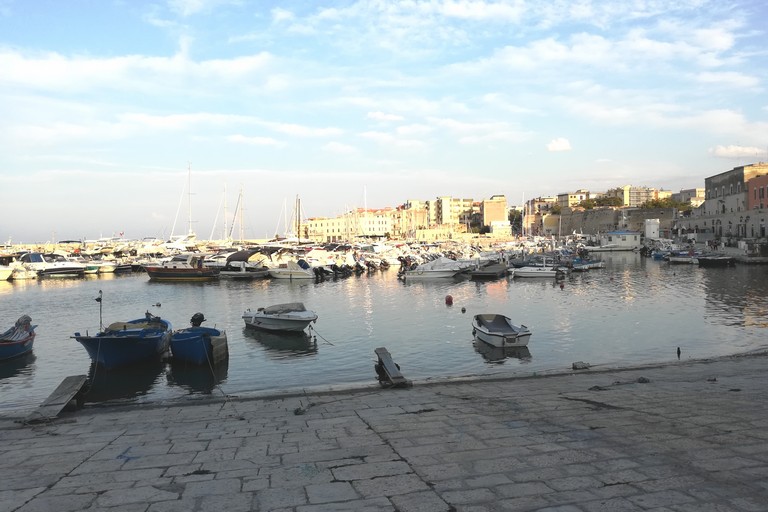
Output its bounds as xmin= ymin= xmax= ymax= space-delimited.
xmin=0 ymin=354 xmax=768 ymax=512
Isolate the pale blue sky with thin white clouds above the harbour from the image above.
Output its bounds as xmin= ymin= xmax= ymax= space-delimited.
xmin=0 ymin=0 xmax=768 ymax=243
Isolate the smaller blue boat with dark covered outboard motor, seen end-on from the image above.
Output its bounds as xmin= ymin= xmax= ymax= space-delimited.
xmin=171 ymin=313 xmax=229 ymax=365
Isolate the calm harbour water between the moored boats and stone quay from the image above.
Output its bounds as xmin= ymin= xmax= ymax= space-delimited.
xmin=0 ymin=253 xmax=768 ymax=414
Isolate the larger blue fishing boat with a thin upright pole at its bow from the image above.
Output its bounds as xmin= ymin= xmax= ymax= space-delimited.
xmin=72 ymin=311 xmax=173 ymax=368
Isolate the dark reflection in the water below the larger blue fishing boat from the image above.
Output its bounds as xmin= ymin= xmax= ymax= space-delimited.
xmin=84 ymin=361 xmax=165 ymax=403
